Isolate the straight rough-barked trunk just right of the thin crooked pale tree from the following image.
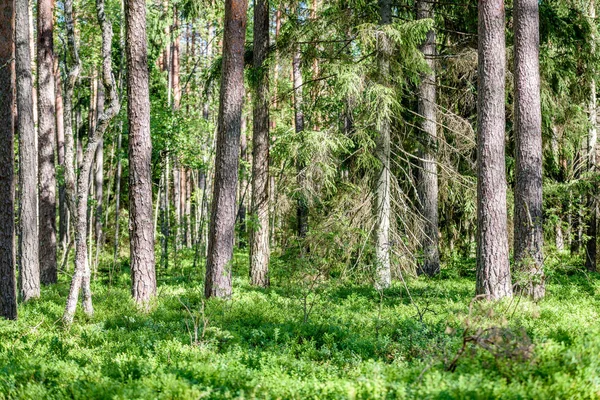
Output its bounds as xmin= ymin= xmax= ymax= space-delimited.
xmin=125 ymin=0 xmax=156 ymax=304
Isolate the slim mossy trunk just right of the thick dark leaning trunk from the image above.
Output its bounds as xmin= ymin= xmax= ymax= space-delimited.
xmin=249 ymin=0 xmax=271 ymax=287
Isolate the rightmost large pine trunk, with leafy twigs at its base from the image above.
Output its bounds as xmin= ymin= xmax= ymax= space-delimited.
xmin=514 ymin=0 xmax=544 ymax=299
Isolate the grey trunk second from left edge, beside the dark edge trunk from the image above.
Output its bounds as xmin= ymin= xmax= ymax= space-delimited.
xmin=15 ymin=0 xmax=40 ymax=301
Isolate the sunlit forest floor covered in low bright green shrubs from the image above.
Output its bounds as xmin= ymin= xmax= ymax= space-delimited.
xmin=0 ymin=250 xmax=600 ymax=399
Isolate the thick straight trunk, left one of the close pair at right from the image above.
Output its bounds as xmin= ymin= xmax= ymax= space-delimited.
xmin=477 ymin=0 xmax=512 ymax=299
